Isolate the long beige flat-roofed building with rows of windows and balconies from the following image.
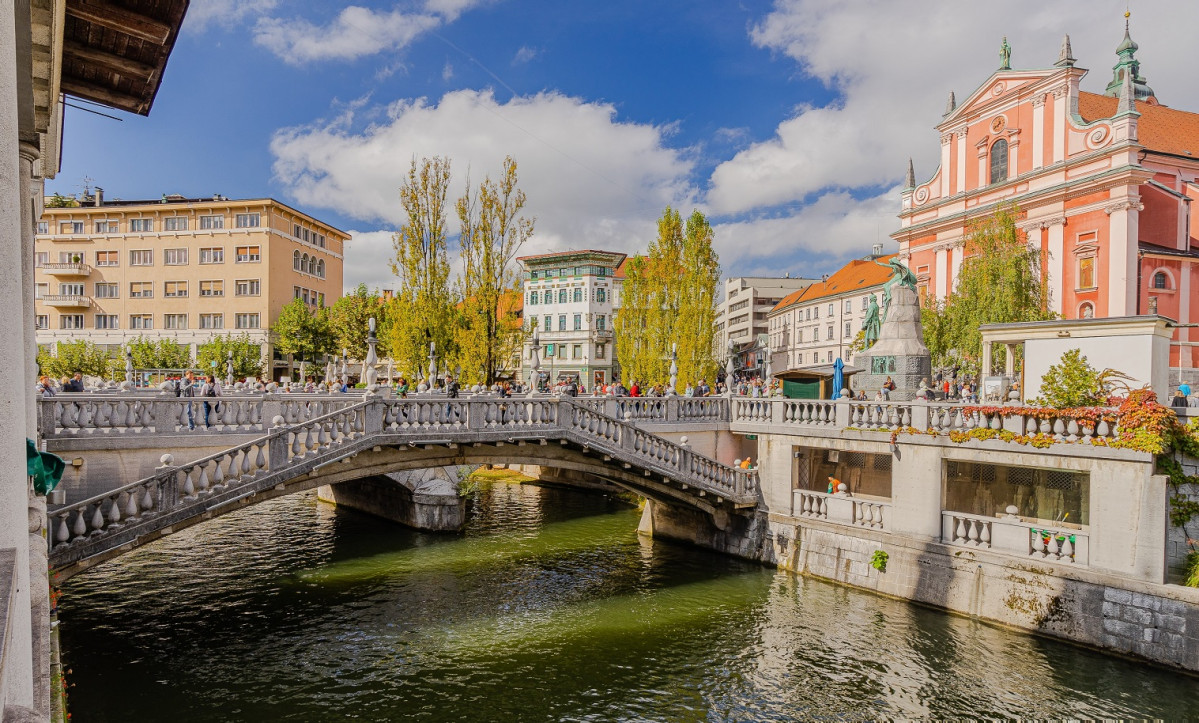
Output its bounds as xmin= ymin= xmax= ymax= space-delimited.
xmin=34 ymin=188 xmax=349 ymax=378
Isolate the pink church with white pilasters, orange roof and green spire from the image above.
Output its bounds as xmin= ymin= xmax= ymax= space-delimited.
xmin=892 ymin=31 xmax=1199 ymax=369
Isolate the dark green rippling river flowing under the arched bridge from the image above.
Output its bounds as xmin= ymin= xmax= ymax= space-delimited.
xmin=60 ymin=482 xmax=1199 ymax=723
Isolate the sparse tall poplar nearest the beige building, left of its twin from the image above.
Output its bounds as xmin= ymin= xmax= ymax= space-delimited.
xmin=387 ymin=157 xmax=457 ymax=378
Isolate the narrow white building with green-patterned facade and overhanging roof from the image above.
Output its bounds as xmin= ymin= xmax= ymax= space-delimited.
xmin=517 ymin=251 xmax=626 ymax=388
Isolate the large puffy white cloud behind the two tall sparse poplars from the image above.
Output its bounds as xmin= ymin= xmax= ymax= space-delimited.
xmin=271 ymin=90 xmax=694 ymax=285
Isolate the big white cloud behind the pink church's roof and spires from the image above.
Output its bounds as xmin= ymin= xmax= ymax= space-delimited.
xmin=707 ymin=0 xmax=1199 ymax=213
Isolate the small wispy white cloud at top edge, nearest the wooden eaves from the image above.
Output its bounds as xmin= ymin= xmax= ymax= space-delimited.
xmin=254 ymin=5 xmax=441 ymax=65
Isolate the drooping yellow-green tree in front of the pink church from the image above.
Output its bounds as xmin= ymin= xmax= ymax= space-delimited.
xmin=921 ymin=204 xmax=1054 ymax=375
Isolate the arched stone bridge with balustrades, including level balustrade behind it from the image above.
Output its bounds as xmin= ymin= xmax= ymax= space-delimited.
xmin=41 ymin=394 xmax=758 ymax=577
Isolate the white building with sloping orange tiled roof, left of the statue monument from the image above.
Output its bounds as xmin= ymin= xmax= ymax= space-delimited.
xmin=767 ymin=245 xmax=896 ymax=396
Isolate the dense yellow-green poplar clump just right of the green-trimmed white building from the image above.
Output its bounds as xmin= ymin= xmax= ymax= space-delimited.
xmin=613 ymin=206 xmax=721 ymax=386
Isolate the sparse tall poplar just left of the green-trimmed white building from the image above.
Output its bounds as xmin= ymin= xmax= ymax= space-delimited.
xmin=454 ymin=156 xmax=535 ymax=385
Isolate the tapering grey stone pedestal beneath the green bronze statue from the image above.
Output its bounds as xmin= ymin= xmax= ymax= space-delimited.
xmin=854 ymin=284 xmax=933 ymax=402
